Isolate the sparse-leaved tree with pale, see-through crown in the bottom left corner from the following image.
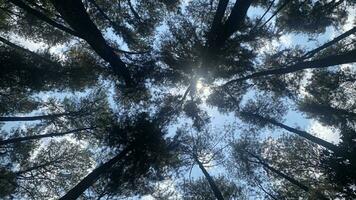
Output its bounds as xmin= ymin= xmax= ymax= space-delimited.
xmin=1 ymin=140 xmax=91 ymax=199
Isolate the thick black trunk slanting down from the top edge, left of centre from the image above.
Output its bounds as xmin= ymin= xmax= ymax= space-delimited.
xmin=51 ymin=0 xmax=134 ymax=86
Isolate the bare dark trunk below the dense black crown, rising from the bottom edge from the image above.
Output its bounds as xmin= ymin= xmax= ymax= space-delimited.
xmin=59 ymin=148 xmax=129 ymax=200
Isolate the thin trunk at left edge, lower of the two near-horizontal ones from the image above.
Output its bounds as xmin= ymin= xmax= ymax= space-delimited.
xmin=0 ymin=127 xmax=94 ymax=145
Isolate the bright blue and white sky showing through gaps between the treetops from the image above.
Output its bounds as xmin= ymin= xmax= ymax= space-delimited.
xmin=3 ymin=0 xmax=356 ymax=200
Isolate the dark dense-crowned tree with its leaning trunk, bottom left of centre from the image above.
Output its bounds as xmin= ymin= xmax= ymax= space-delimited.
xmin=60 ymin=113 xmax=179 ymax=199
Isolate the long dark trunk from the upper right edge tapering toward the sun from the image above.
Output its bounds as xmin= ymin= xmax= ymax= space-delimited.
xmin=223 ymin=49 xmax=356 ymax=86
